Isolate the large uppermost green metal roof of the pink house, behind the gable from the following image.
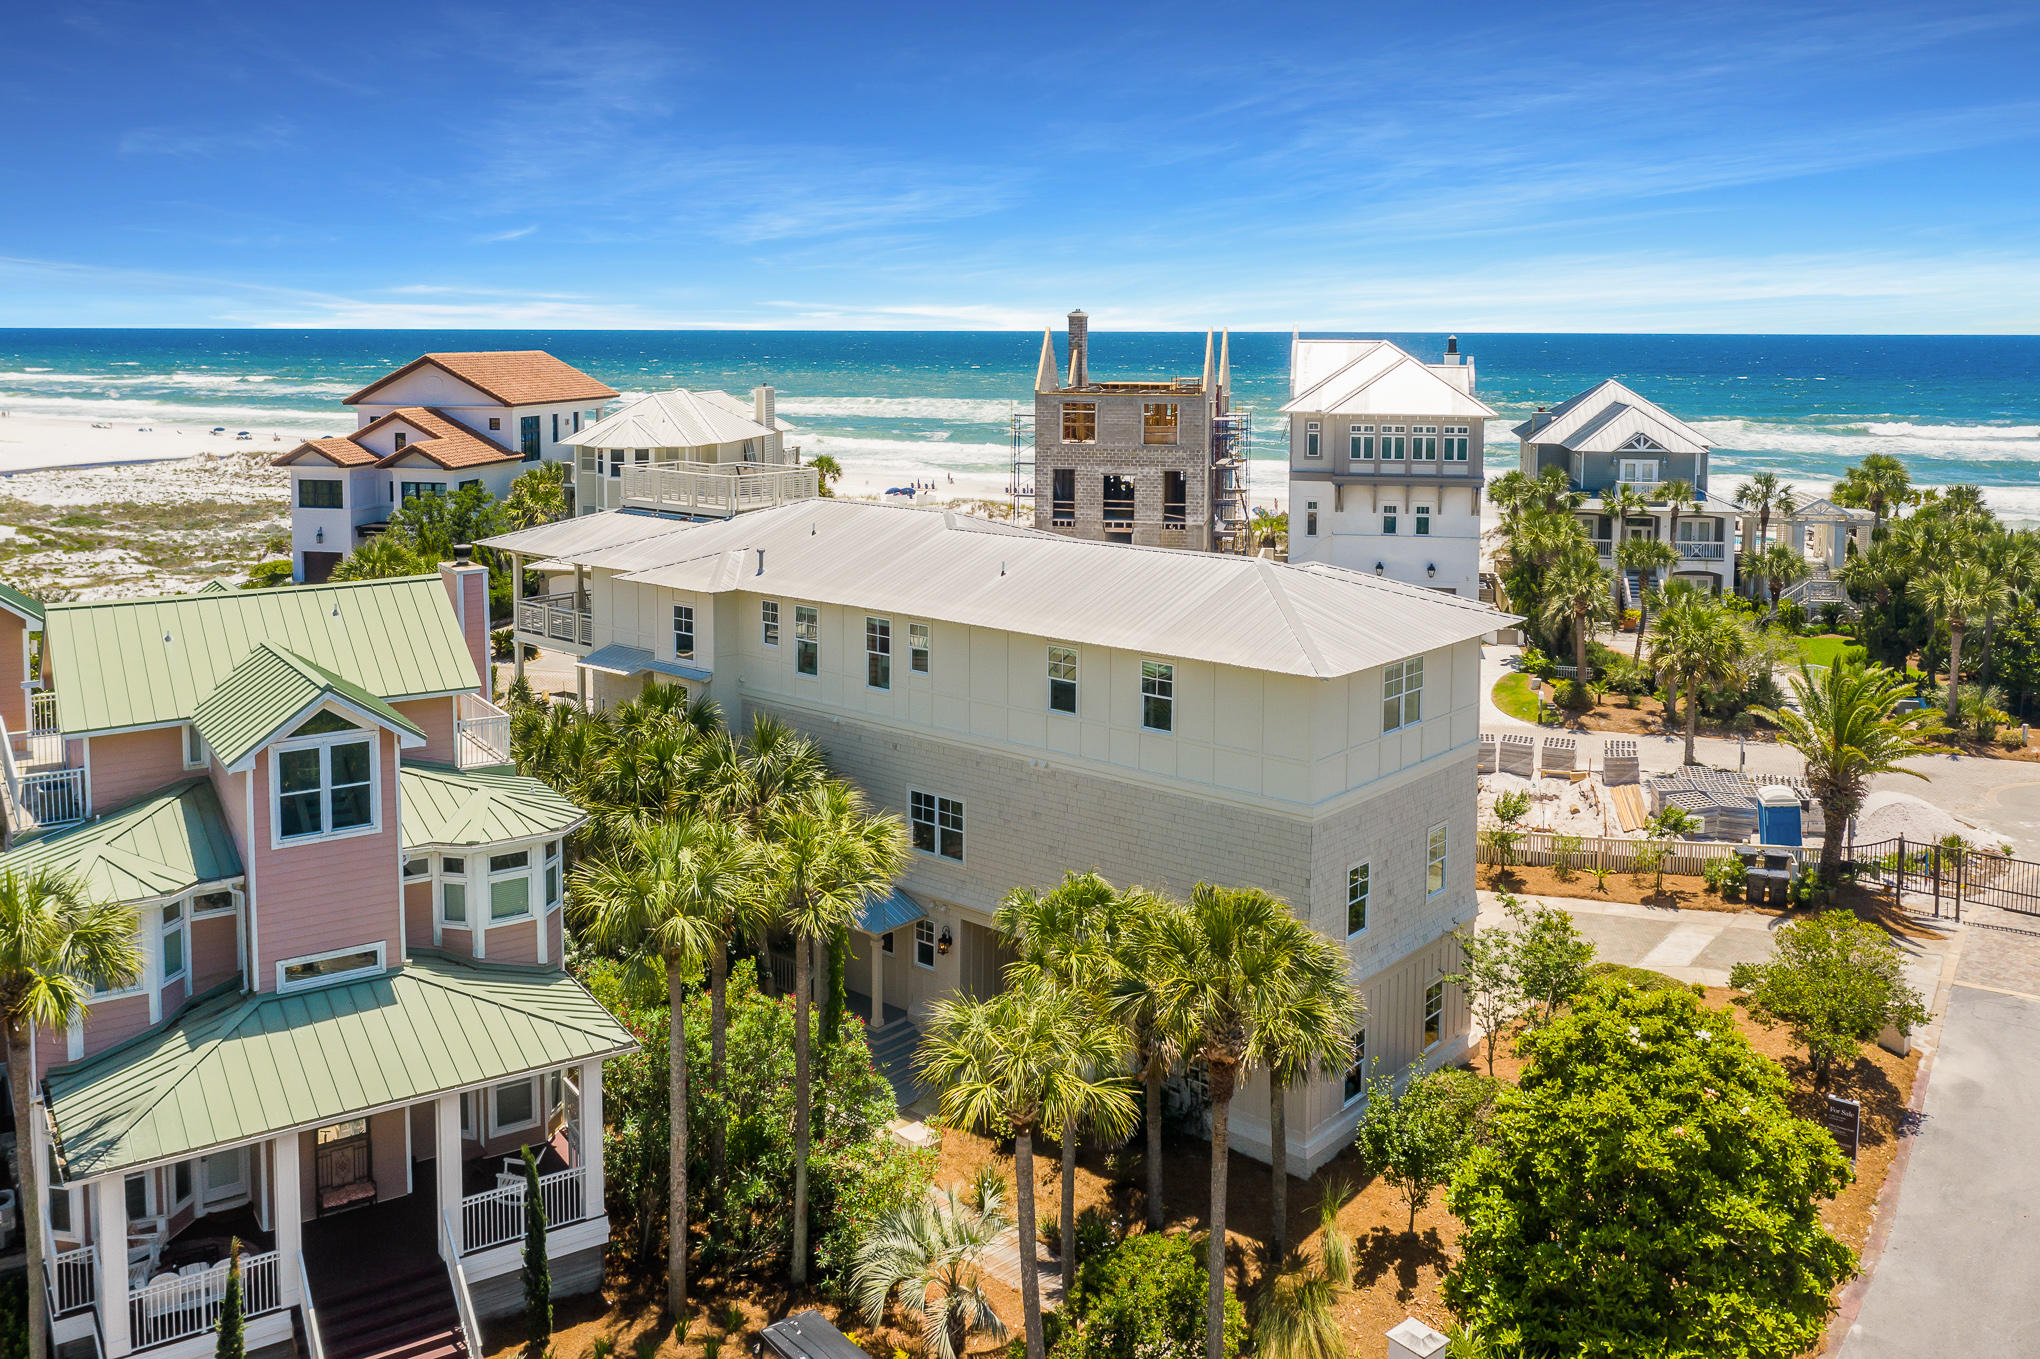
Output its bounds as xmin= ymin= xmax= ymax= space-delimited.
xmin=45 ymin=575 xmax=481 ymax=737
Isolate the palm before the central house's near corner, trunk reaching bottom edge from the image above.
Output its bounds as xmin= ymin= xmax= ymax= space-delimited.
xmin=1151 ymin=882 xmax=1346 ymax=1359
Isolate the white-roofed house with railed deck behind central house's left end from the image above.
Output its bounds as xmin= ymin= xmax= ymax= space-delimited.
xmin=567 ymin=386 xmax=820 ymax=518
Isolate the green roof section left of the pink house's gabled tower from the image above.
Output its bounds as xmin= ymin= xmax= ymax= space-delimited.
xmin=0 ymin=779 xmax=241 ymax=902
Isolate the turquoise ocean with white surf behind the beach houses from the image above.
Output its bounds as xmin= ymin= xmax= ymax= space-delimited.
xmin=0 ymin=329 xmax=2040 ymax=518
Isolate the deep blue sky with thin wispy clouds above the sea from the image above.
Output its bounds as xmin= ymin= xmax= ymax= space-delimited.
xmin=0 ymin=0 xmax=2040 ymax=333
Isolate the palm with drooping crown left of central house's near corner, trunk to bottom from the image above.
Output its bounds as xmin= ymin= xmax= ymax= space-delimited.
xmin=914 ymin=982 xmax=1134 ymax=1359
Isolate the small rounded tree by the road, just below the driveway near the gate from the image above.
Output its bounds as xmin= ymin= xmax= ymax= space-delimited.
xmin=1728 ymin=910 xmax=1928 ymax=1092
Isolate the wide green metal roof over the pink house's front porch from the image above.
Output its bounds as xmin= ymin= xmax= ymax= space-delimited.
xmin=45 ymin=953 xmax=636 ymax=1179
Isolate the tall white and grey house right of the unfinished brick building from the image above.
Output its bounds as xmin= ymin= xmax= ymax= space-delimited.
xmin=1283 ymin=335 xmax=1495 ymax=600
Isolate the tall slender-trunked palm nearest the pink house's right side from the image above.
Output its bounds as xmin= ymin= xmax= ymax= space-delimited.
xmin=573 ymin=816 xmax=759 ymax=1316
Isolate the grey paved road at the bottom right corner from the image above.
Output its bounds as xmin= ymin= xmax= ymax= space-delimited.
xmin=1842 ymin=930 xmax=2040 ymax=1359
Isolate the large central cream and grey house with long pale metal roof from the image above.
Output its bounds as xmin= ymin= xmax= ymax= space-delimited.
xmin=490 ymin=500 xmax=1506 ymax=1167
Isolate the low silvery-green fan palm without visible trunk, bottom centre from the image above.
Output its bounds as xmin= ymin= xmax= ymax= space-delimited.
xmin=851 ymin=1186 xmax=1010 ymax=1359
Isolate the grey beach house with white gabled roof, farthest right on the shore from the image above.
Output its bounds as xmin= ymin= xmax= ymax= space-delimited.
xmin=1514 ymin=378 xmax=1746 ymax=608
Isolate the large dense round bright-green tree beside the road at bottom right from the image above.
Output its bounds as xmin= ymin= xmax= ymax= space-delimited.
xmin=1444 ymin=984 xmax=1856 ymax=1359
